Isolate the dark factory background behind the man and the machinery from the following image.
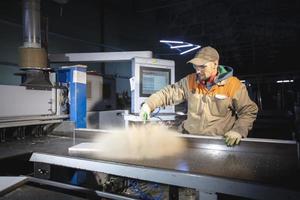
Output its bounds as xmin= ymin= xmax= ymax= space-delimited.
xmin=0 ymin=0 xmax=300 ymax=139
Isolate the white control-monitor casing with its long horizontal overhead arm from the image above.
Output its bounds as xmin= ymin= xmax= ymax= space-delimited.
xmin=49 ymin=51 xmax=175 ymax=127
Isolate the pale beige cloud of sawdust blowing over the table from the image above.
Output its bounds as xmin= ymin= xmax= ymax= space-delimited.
xmin=93 ymin=124 xmax=186 ymax=159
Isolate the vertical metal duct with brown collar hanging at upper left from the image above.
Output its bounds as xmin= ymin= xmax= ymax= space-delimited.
xmin=19 ymin=0 xmax=53 ymax=89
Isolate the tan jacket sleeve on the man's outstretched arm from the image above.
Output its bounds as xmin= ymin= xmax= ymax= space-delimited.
xmin=146 ymin=77 xmax=187 ymax=111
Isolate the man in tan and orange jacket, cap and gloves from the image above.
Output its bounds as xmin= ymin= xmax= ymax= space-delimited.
xmin=140 ymin=46 xmax=258 ymax=146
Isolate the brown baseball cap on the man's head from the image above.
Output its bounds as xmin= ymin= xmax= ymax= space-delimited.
xmin=187 ymin=46 xmax=219 ymax=65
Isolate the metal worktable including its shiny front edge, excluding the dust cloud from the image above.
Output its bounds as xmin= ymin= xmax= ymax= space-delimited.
xmin=24 ymin=130 xmax=300 ymax=199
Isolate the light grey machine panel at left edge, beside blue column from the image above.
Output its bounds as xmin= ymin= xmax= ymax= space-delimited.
xmin=0 ymin=85 xmax=69 ymax=128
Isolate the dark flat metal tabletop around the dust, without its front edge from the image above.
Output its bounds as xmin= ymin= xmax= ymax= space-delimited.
xmin=0 ymin=132 xmax=299 ymax=187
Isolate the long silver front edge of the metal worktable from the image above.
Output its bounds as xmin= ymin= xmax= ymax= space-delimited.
xmin=30 ymin=153 xmax=300 ymax=200
